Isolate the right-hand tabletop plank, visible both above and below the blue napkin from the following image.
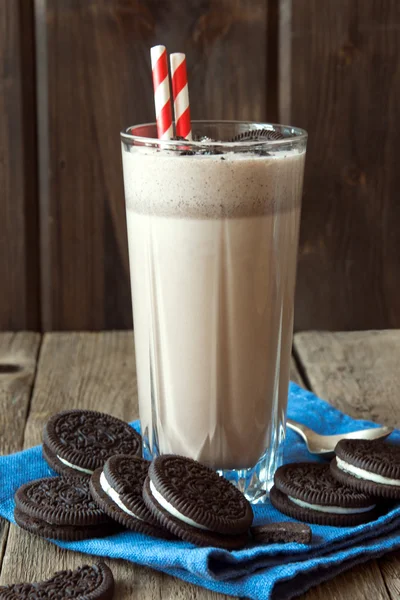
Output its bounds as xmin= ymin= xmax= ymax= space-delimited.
xmin=294 ymin=331 xmax=400 ymax=600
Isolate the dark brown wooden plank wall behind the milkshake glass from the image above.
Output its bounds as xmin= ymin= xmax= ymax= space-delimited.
xmin=0 ymin=0 xmax=400 ymax=330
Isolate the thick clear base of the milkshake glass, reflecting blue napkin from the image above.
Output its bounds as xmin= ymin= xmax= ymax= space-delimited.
xmin=142 ymin=427 xmax=284 ymax=504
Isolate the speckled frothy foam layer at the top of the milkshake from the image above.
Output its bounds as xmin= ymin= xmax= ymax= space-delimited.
xmin=122 ymin=148 xmax=304 ymax=218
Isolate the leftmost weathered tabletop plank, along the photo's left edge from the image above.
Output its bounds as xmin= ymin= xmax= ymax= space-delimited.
xmin=0 ymin=333 xmax=40 ymax=569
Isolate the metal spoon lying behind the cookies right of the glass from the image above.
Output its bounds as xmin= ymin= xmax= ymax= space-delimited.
xmin=286 ymin=419 xmax=393 ymax=456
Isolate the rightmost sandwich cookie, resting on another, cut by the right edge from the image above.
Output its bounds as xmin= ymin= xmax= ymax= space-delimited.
xmin=331 ymin=440 xmax=400 ymax=500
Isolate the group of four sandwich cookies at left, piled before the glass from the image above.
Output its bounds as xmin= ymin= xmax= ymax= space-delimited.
xmin=14 ymin=410 xmax=253 ymax=550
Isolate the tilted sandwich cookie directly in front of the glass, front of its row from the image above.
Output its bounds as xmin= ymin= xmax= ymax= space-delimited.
xmin=143 ymin=454 xmax=253 ymax=550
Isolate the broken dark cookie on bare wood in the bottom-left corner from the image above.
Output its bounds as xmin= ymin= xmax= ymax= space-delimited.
xmin=0 ymin=562 xmax=114 ymax=600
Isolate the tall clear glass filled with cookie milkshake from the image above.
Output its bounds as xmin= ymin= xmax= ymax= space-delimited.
xmin=121 ymin=121 xmax=307 ymax=501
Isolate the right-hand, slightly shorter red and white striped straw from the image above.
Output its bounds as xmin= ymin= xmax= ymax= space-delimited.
xmin=170 ymin=52 xmax=192 ymax=140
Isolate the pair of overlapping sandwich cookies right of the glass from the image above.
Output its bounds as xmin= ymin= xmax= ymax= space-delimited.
xmin=270 ymin=440 xmax=400 ymax=527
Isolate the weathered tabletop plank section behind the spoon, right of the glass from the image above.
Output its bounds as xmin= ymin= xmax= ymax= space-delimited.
xmin=294 ymin=330 xmax=400 ymax=427
